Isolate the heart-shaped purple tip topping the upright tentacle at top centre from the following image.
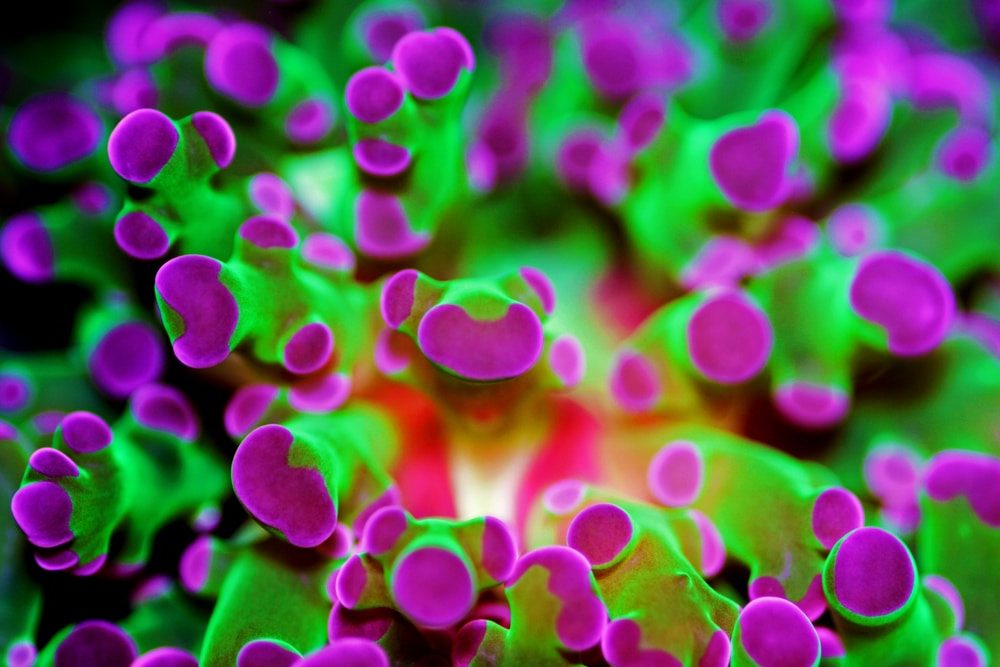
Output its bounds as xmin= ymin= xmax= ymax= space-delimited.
xmin=392 ymin=31 xmax=471 ymax=100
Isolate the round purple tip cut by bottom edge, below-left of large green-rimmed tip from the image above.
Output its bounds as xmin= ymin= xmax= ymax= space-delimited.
xmin=735 ymin=597 xmax=820 ymax=667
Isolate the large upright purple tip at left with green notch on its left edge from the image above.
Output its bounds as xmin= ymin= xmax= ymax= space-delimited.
xmin=156 ymin=255 xmax=240 ymax=368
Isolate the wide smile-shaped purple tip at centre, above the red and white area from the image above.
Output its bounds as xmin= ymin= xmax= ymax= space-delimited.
xmin=417 ymin=303 xmax=544 ymax=381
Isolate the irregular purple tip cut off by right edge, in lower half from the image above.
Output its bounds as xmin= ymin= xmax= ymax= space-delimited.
xmin=924 ymin=451 xmax=1000 ymax=528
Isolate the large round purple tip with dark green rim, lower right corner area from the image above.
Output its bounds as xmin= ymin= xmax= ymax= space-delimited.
xmin=823 ymin=528 xmax=917 ymax=622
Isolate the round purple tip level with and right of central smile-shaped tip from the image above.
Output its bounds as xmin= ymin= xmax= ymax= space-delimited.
xmin=687 ymin=292 xmax=774 ymax=384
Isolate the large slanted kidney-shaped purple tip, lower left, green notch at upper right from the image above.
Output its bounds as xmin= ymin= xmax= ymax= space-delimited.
xmin=233 ymin=424 xmax=337 ymax=547
